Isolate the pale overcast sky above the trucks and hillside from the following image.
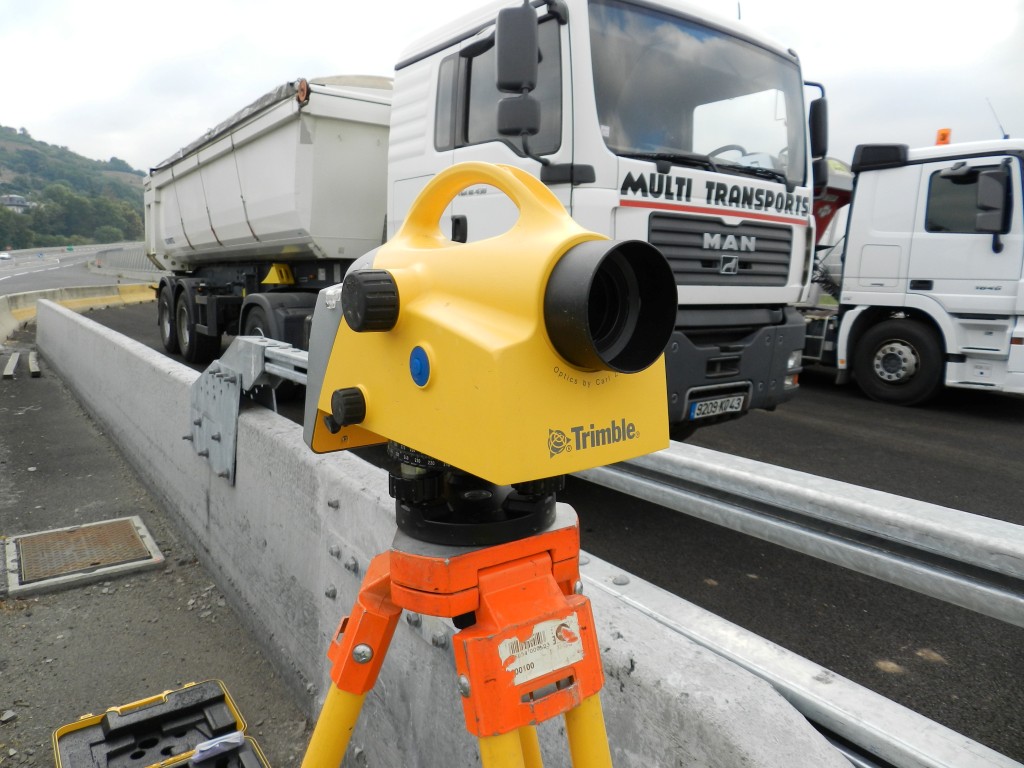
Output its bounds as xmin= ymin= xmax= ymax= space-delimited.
xmin=0 ymin=0 xmax=1024 ymax=170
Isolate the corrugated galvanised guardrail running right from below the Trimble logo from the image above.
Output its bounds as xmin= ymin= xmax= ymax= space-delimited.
xmin=579 ymin=443 xmax=1024 ymax=627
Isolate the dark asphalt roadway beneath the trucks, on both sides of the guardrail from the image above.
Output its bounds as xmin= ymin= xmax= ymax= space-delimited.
xmin=9 ymin=301 xmax=1024 ymax=762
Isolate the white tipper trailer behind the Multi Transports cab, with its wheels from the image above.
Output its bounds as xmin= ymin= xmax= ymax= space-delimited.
xmin=145 ymin=77 xmax=391 ymax=361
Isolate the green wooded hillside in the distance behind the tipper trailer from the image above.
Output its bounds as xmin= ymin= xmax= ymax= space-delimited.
xmin=0 ymin=126 xmax=144 ymax=250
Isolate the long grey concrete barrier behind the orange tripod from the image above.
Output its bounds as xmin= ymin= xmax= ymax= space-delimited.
xmin=37 ymin=301 xmax=849 ymax=768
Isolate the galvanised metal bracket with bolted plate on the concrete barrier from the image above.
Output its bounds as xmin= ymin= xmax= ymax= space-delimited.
xmin=185 ymin=336 xmax=308 ymax=485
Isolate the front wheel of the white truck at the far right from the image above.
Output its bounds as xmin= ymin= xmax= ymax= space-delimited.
xmin=853 ymin=319 xmax=945 ymax=406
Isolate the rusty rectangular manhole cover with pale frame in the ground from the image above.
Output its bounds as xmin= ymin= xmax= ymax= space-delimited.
xmin=6 ymin=517 xmax=164 ymax=597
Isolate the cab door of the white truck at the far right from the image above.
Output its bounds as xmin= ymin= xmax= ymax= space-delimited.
xmin=907 ymin=157 xmax=1024 ymax=314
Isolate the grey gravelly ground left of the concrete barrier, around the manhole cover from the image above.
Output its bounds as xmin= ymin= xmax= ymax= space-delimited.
xmin=0 ymin=326 xmax=310 ymax=768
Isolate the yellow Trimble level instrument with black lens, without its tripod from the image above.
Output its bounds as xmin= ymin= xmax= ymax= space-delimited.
xmin=304 ymin=163 xmax=677 ymax=484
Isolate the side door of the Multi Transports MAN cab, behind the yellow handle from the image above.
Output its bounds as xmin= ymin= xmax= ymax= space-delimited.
xmin=442 ymin=15 xmax=572 ymax=241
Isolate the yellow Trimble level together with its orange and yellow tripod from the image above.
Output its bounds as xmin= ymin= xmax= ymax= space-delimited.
xmin=303 ymin=163 xmax=676 ymax=768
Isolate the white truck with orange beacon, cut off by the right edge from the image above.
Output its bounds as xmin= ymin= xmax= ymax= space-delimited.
xmin=804 ymin=139 xmax=1024 ymax=406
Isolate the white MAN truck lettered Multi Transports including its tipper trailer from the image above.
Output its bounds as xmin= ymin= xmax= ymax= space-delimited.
xmin=145 ymin=0 xmax=826 ymax=436
